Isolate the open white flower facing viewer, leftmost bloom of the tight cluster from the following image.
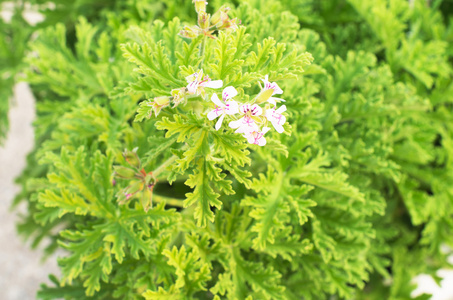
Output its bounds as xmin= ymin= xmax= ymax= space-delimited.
xmin=208 ymin=86 xmax=239 ymax=130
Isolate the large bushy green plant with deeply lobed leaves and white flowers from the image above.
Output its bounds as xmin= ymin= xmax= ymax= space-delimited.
xmin=9 ymin=0 xmax=453 ymax=299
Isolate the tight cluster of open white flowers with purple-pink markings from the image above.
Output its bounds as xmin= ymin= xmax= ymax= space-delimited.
xmin=207 ymin=71 xmax=286 ymax=146
